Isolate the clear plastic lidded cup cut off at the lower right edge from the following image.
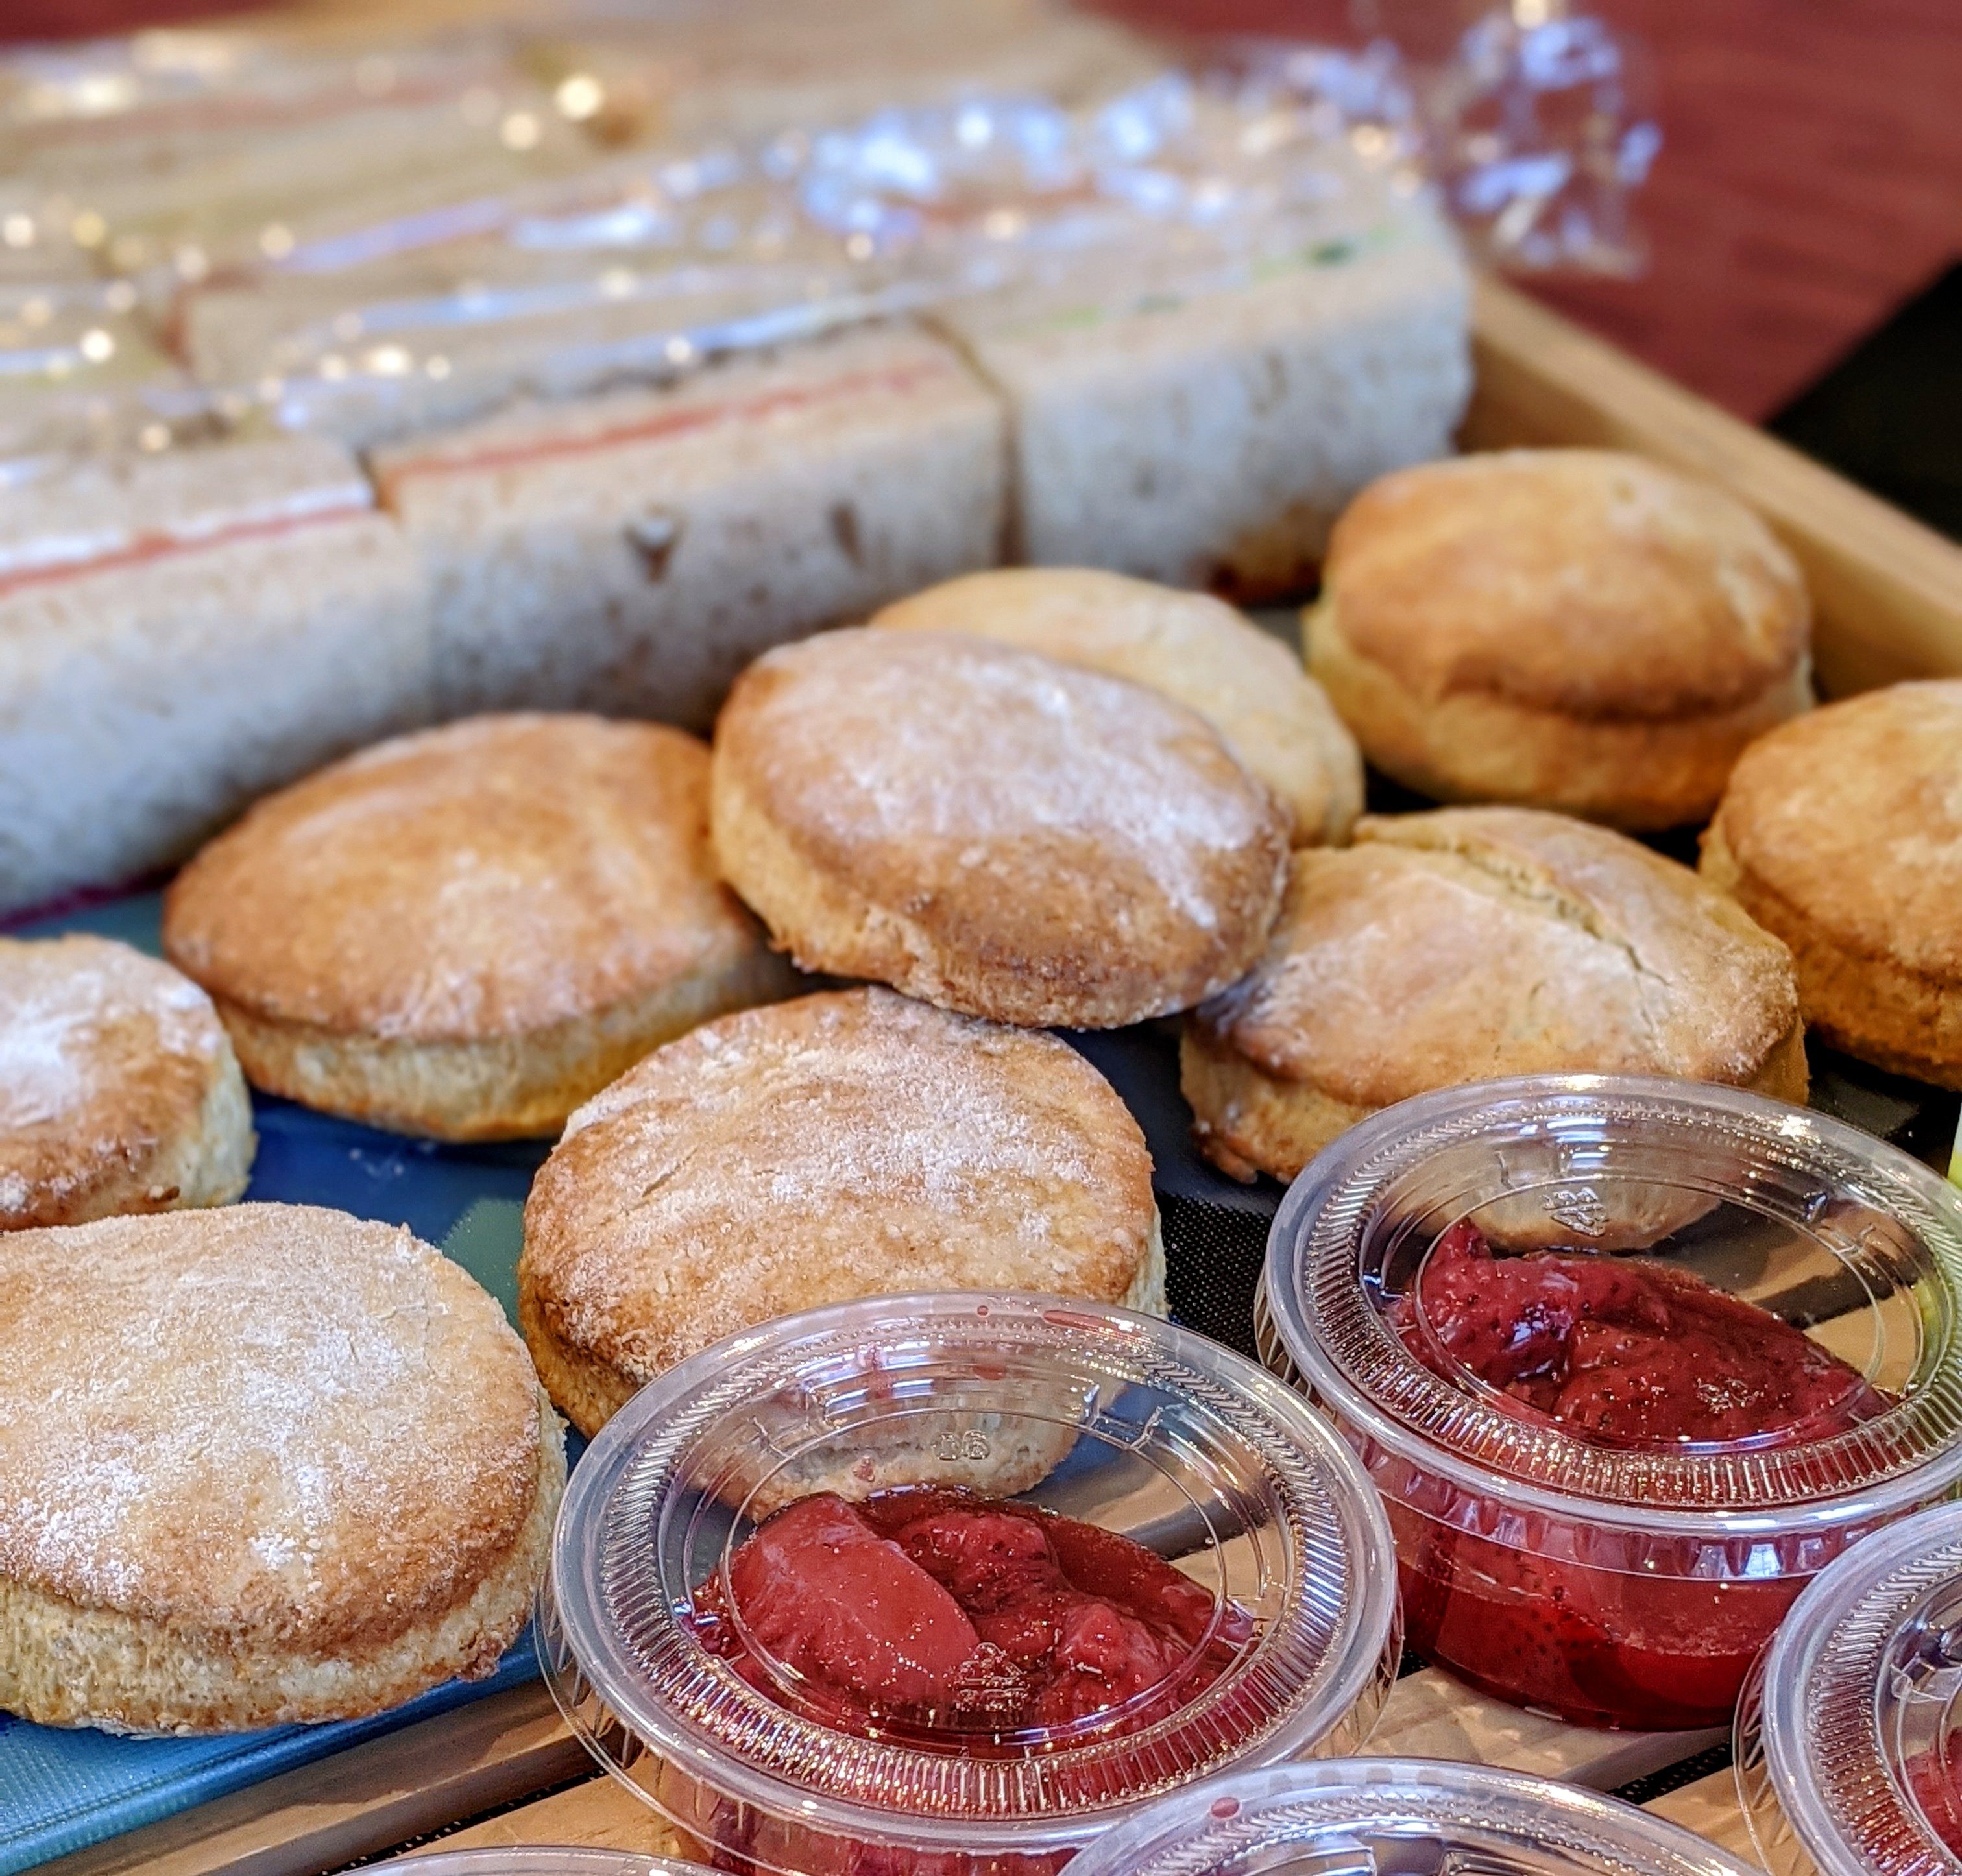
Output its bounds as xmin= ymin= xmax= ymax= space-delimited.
xmin=1736 ymin=1505 xmax=1962 ymax=1876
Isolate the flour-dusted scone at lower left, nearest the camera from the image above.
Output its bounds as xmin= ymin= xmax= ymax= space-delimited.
xmin=0 ymin=1205 xmax=565 ymax=1733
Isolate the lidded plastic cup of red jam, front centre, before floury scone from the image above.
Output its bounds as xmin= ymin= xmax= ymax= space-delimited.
xmin=540 ymin=1293 xmax=1399 ymax=1876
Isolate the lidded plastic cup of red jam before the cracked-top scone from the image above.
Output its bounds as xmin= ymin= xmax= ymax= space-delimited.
xmin=1263 ymin=1077 xmax=1962 ymax=1729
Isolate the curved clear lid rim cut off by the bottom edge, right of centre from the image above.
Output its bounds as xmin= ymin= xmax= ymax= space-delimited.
xmin=1071 ymin=1758 xmax=1754 ymax=1876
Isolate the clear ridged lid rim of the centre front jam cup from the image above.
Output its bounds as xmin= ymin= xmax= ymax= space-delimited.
xmin=538 ymin=1292 xmax=1401 ymax=1853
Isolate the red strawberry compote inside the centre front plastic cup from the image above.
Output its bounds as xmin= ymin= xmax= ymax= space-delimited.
xmin=697 ymin=1485 xmax=1252 ymax=1754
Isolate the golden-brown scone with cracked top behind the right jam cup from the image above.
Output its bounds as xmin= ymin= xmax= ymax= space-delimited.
xmin=1181 ymin=808 xmax=1805 ymax=1179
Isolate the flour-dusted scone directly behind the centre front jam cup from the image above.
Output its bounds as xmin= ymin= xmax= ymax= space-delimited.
xmin=518 ymin=987 xmax=1165 ymax=1452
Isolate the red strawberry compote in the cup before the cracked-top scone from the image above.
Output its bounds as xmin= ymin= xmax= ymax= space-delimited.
xmin=1391 ymin=1223 xmax=1889 ymax=1727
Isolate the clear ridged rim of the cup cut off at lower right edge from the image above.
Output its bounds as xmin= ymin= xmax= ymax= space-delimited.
xmin=1732 ymin=1503 xmax=1962 ymax=1876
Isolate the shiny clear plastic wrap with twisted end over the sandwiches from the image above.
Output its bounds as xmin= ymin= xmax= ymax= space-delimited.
xmin=0 ymin=0 xmax=1654 ymax=463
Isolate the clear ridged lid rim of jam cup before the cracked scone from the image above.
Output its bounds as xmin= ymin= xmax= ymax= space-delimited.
xmin=1261 ymin=1076 xmax=1962 ymax=1543
